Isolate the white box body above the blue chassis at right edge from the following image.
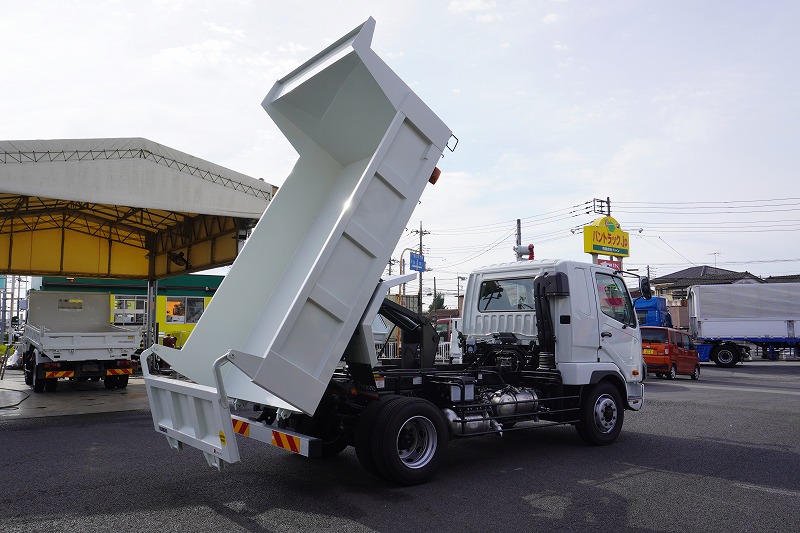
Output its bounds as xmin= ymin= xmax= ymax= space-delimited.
xmin=688 ymin=283 xmax=800 ymax=339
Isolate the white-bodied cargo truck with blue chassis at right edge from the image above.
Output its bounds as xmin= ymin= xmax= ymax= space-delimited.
xmin=687 ymin=283 xmax=800 ymax=368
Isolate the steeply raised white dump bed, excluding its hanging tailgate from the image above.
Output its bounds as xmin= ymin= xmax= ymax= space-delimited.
xmin=153 ymin=19 xmax=451 ymax=413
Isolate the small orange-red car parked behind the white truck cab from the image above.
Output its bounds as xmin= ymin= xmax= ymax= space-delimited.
xmin=642 ymin=326 xmax=700 ymax=379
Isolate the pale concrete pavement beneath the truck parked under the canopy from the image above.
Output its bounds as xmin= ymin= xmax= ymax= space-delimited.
xmin=0 ymin=370 xmax=150 ymax=420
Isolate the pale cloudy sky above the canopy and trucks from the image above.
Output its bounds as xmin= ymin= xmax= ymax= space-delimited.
xmin=0 ymin=0 xmax=800 ymax=306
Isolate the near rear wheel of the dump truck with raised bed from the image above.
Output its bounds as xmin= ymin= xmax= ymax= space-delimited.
xmin=372 ymin=397 xmax=448 ymax=485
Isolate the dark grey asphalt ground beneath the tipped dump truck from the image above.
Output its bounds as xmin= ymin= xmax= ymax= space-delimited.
xmin=0 ymin=361 xmax=800 ymax=533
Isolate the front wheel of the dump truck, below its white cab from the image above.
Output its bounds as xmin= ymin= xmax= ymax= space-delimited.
xmin=575 ymin=381 xmax=625 ymax=446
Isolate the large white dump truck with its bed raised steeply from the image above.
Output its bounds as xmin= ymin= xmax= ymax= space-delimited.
xmin=142 ymin=19 xmax=643 ymax=484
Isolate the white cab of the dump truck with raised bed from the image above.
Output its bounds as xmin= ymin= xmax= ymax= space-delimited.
xmin=462 ymin=260 xmax=642 ymax=400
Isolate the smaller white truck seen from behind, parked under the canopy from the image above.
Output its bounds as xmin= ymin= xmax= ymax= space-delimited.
xmin=23 ymin=291 xmax=141 ymax=392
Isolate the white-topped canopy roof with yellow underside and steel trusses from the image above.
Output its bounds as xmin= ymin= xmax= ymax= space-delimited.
xmin=0 ymin=138 xmax=277 ymax=281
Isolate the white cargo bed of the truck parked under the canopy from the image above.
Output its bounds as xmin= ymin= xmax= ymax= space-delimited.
xmin=25 ymin=291 xmax=141 ymax=361
